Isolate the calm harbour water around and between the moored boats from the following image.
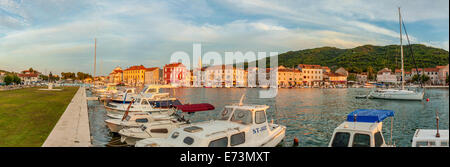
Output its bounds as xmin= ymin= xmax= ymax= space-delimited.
xmin=88 ymin=88 xmax=449 ymax=147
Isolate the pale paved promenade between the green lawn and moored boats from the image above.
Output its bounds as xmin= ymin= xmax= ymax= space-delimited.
xmin=42 ymin=87 xmax=91 ymax=147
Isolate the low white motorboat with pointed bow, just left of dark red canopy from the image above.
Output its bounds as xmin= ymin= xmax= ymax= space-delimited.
xmin=105 ymin=112 xmax=177 ymax=133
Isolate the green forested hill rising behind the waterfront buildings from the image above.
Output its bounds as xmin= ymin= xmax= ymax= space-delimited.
xmin=267 ymin=44 xmax=449 ymax=72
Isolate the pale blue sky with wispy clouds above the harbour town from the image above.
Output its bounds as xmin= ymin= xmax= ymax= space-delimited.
xmin=0 ymin=0 xmax=449 ymax=75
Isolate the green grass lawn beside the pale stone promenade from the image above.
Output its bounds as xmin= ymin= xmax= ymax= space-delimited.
xmin=0 ymin=87 xmax=78 ymax=147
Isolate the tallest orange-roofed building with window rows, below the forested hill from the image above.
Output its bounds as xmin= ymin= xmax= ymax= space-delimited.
xmin=297 ymin=64 xmax=324 ymax=86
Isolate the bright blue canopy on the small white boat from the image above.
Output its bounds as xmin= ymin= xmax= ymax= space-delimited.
xmin=347 ymin=109 xmax=394 ymax=123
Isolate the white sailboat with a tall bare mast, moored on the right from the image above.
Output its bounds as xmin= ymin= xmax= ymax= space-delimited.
xmin=368 ymin=8 xmax=424 ymax=100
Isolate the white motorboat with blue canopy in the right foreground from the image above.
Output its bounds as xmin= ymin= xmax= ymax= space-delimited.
xmin=328 ymin=109 xmax=394 ymax=147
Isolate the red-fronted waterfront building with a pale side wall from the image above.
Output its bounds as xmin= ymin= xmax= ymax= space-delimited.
xmin=163 ymin=63 xmax=187 ymax=86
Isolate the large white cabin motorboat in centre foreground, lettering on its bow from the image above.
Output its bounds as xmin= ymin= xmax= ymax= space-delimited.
xmin=135 ymin=104 xmax=286 ymax=147
